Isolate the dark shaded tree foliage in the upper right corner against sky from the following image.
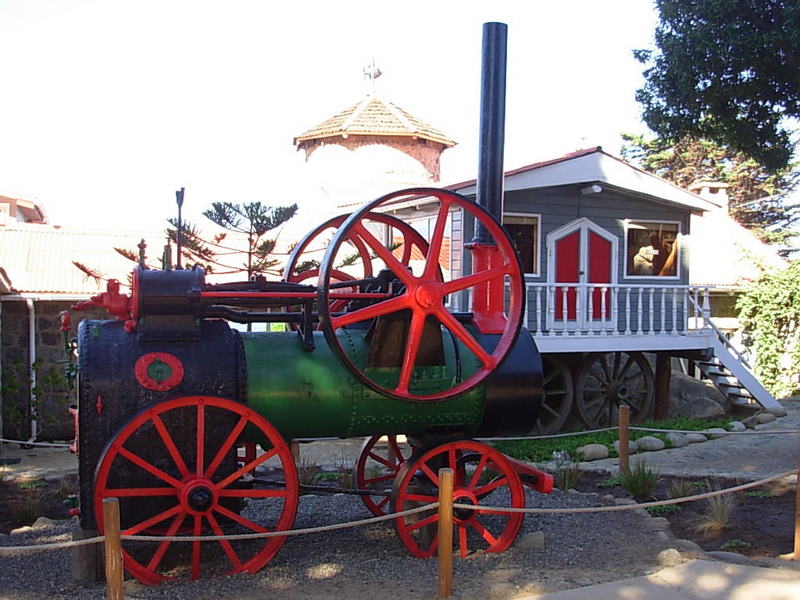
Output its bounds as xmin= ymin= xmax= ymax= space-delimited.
xmin=634 ymin=0 xmax=800 ymax=170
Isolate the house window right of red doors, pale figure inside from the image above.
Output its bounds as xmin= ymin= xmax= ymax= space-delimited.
xmin=625 ymin=221 xmax=680 ymax=277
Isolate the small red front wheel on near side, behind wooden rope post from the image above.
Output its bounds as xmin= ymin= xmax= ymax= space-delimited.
xmin=392 ymin=440 xmax=525 ymax=558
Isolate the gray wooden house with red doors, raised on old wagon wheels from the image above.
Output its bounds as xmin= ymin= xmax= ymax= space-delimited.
xmin=380 ymin=147 xmax=783 ymax=431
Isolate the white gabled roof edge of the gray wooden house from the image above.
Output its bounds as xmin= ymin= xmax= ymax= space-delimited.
xmin=447 ymin=146 xmax=720 ymax=211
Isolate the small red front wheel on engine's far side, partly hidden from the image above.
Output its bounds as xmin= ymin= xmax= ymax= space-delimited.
xmin=356 ymin=435 xmax=411 ymax=517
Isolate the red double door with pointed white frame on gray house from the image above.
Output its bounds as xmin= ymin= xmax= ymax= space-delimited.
xmin=551 ymin=219 xmax=616 ymax=327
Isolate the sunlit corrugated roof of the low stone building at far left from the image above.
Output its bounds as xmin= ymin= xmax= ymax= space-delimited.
xmin=0 ymin=223 xmax=165 ymax=296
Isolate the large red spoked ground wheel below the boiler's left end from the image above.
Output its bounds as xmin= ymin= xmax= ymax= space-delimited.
xmin=94 ymin=396 xmax=299 ymax=585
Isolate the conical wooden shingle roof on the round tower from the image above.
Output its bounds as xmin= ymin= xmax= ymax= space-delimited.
xmin=294 ymin=96 xmax=455 ymax=148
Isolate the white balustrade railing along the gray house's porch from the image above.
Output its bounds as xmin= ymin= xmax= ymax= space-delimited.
xmin=523 ymin=282 xmax=712 ymax=336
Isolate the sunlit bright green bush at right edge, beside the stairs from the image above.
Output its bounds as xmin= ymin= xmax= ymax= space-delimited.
xmin=736 ymin=261 xmax=800 ymax=396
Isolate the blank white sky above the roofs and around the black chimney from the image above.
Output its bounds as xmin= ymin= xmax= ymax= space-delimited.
xmin=0 ymin=0 xmax=657 ymax=229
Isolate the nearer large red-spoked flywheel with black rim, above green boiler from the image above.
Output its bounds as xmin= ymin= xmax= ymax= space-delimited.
xmin=317 ymin=188 xmax=524 ymax=402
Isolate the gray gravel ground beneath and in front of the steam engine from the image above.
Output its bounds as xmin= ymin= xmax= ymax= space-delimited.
xmin=0 ymin=490 xmax=668 ymax=600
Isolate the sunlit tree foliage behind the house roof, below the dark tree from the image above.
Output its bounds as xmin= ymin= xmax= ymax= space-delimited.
xmin=621 ymin=134 xmax=800 ymax=243
